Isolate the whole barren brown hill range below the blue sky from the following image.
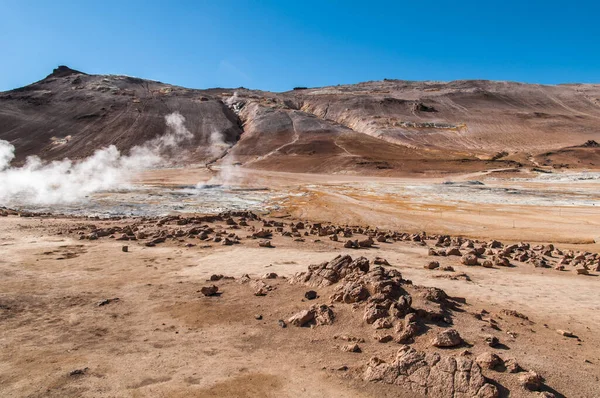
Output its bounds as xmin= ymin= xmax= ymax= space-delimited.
xmin=0 ymin=66 xmax=600 ymax=174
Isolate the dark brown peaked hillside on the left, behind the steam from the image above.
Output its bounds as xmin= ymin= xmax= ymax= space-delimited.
xmin=0 ymin=66 xmax=242 ymax=160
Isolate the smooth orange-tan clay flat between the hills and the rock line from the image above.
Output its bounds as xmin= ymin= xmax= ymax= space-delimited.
xmin=136 ymin=168 xmax=600 ymax=251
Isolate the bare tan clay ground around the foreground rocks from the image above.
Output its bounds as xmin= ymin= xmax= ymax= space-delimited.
xmin=0 ymin=207 xmax=600 ymax=397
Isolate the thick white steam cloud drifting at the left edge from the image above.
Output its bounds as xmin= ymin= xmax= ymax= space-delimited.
xmin=0 ymin=112 xmax=193 ymax=206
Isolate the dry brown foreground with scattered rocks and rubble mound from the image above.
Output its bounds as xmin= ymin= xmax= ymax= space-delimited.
xmin=0 ymin=213 xmax=600 ymax=397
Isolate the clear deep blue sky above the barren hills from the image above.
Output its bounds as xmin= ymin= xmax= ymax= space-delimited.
xmin=0 ymin=0 xmax=600 ymax=91
